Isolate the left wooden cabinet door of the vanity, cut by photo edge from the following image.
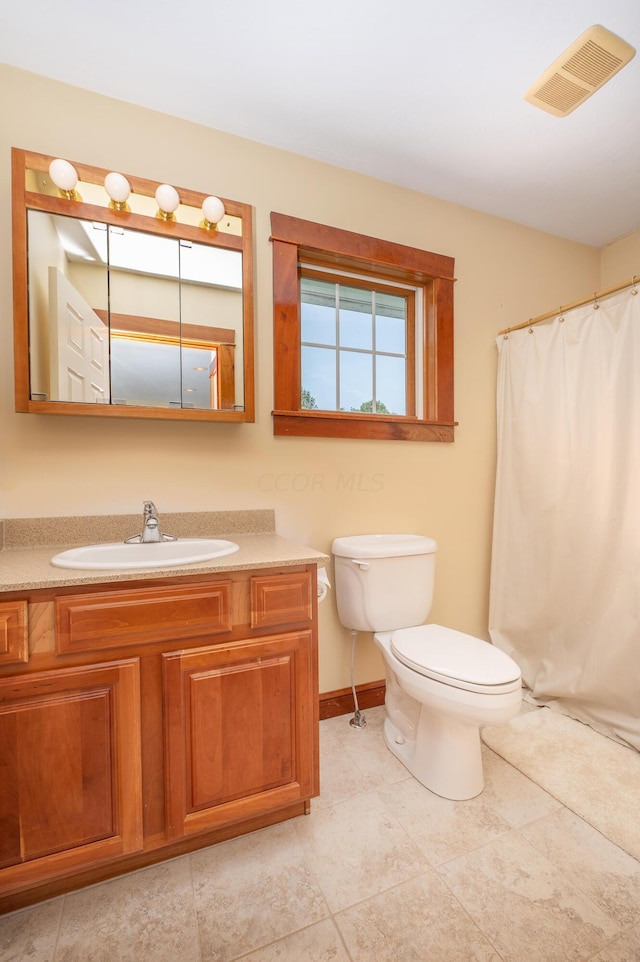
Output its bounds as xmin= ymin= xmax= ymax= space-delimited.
xmin=0 ymin=659 xmax=142 ymax=893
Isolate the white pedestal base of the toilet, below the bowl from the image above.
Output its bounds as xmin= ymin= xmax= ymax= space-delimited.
xmin=384 ymin=705 xmax=484 ymax=801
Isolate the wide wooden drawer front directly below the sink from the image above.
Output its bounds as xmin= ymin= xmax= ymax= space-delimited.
xmin=55 ymin=581 xmax=232 ymax=654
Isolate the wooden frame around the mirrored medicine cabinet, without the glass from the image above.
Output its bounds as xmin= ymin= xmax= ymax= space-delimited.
xmin=11 ymin=147 xmax=255 ymax=422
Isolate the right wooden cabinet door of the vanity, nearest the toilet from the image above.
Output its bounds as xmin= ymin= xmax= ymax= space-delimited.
xmin=163 ymin=631 xmax=315 ymax=836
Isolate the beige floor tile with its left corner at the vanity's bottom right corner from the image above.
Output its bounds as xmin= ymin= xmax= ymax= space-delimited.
xmin=296 ymin=792 xmax=429 ymax=912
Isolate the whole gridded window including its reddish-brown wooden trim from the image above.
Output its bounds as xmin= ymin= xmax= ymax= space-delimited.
xmin=271 ymin=213 xmax=455 ymax=441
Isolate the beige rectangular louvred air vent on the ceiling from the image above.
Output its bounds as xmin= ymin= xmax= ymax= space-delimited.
xmin=524 ymin=26 xmax=635 ymax=117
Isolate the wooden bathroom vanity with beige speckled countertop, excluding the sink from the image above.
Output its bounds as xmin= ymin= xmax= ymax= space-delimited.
xmin=0 ymin=512 xmax=327 ymax=911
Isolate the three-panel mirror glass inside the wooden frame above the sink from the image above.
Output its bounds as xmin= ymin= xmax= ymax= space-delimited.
xmin=28 ymin=211 xmax=243 ymax=410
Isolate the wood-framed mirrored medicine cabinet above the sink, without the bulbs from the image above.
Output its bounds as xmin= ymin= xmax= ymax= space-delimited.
xmin=13 ymin=148 xmax=254 ymax=421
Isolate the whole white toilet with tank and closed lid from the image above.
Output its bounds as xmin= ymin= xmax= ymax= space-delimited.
xmin=332 ymin=534 xmax=522 ymax=800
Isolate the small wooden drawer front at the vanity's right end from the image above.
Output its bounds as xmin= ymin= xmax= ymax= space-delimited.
xmin=251 ymin=571 xmax=313 ymax=628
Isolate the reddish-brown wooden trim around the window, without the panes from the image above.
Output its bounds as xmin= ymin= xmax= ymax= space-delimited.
xmin=271 ymin=212 xmax=457 ymax=441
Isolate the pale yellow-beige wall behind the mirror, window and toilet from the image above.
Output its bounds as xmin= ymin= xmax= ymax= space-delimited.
xmin=0 ymin=67 xmax=601 ymax=692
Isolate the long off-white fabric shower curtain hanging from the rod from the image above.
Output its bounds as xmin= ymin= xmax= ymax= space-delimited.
xmin=489 ymin=288 xmax=640 ymax=750
